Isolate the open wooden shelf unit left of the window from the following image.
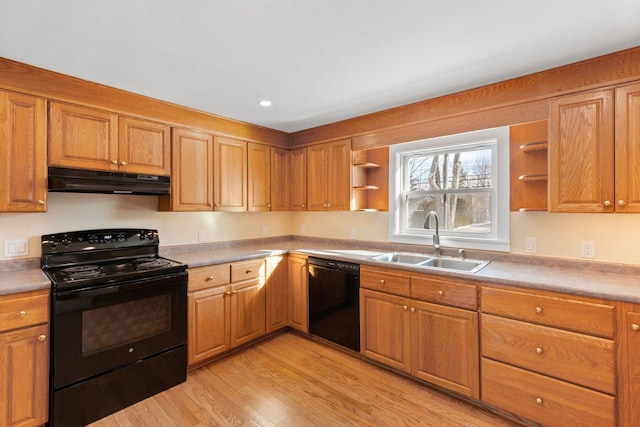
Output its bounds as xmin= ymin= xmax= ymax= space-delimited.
xmin=351 ymin=147 xmax=389 ymax=212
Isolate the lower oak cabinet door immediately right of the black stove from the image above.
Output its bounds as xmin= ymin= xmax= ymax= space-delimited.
xmin=188 ymin=286 xmax=231 ymax=365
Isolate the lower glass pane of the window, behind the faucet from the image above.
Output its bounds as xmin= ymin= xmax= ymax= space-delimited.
xmin=405 ymin=192 xmax=491 ymax=233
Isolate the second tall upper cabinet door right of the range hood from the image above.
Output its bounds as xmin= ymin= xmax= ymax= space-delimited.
xmin=213 ymin=136 xmax=247 ymax=212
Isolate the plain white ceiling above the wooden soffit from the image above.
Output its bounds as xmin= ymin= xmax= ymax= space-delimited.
xmin=0 ymin=0 xmax=640 ymax=132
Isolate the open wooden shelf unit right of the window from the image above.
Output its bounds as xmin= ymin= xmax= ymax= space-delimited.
xmin=510 ymin=120 xmax=549 ymax=212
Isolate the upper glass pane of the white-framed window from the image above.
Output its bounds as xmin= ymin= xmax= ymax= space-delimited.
xmin=405 ymin=148 xmax=492 ymax=191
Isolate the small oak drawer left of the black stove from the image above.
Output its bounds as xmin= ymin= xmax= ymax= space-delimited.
xmin=0 ymin=291 xmax=49 ymax=331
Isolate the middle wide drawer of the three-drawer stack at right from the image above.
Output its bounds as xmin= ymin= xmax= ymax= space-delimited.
xmin=481 ymin=314 xmax=615 ymax=394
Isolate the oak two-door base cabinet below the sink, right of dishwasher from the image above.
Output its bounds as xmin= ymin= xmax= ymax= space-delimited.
xmin=360 ymin=267 xmax=480 ymax=398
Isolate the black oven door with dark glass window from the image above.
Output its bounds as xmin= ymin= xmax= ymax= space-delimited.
xmin=51 ymin=272 xmax=187 ymax=389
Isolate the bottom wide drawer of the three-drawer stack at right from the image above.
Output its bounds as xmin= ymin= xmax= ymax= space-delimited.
xmin=482 ymin=358 xmax=616 ymax=427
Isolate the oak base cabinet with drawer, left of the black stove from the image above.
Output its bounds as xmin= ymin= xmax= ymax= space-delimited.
xmin=0 ymin=291 xmax=49 ymax=427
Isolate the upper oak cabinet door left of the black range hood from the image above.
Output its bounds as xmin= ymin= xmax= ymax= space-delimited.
xmin=0 ymin=91 xmax=47 ymax=212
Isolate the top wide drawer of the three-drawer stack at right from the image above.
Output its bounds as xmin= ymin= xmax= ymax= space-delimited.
xmin=480 ymin=286 xmax=615 ymax=338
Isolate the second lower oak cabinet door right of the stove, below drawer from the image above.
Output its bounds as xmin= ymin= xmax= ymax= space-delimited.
xmin=231 ymin=277 xmax=265 ymax=347
